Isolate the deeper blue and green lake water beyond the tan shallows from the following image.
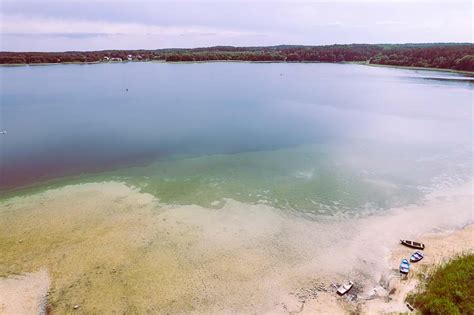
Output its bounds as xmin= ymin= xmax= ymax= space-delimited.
xmin=0 ymin=62 xmax=474 ymax=216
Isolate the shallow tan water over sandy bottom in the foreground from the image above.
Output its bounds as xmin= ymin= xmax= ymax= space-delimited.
xmin=0 ymin=182 xmax=473 ymax=313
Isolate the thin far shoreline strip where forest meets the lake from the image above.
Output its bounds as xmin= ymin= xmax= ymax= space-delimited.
xmin=0 ymin=60 xmax=474 ymax=77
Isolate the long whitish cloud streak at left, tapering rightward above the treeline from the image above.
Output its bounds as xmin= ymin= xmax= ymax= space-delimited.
xmin=0 ymin=15 xmax=267 ymax=37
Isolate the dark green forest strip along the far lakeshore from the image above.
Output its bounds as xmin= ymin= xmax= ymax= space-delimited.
xmin=0 ymin=43 xmax=474 ymax=71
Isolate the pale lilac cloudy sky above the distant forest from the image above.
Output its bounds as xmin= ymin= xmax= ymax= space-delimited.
xmin=0 ymin=0 xmax=473 ymax=51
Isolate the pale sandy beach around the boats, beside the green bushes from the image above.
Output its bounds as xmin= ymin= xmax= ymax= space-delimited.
xmin=300 ymin=223 xmax=474 ymax=315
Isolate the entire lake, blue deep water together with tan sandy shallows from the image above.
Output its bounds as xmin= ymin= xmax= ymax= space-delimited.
xmin=0 ymin=62 xmax=473 ymax=314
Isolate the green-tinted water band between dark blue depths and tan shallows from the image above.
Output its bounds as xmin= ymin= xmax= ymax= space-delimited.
xmin=0 ymin=144 xmax=426 ymax=215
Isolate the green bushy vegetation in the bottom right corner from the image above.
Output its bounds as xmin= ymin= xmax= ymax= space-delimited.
xmin=407 ymin=254 xmax=474 ymax=314
